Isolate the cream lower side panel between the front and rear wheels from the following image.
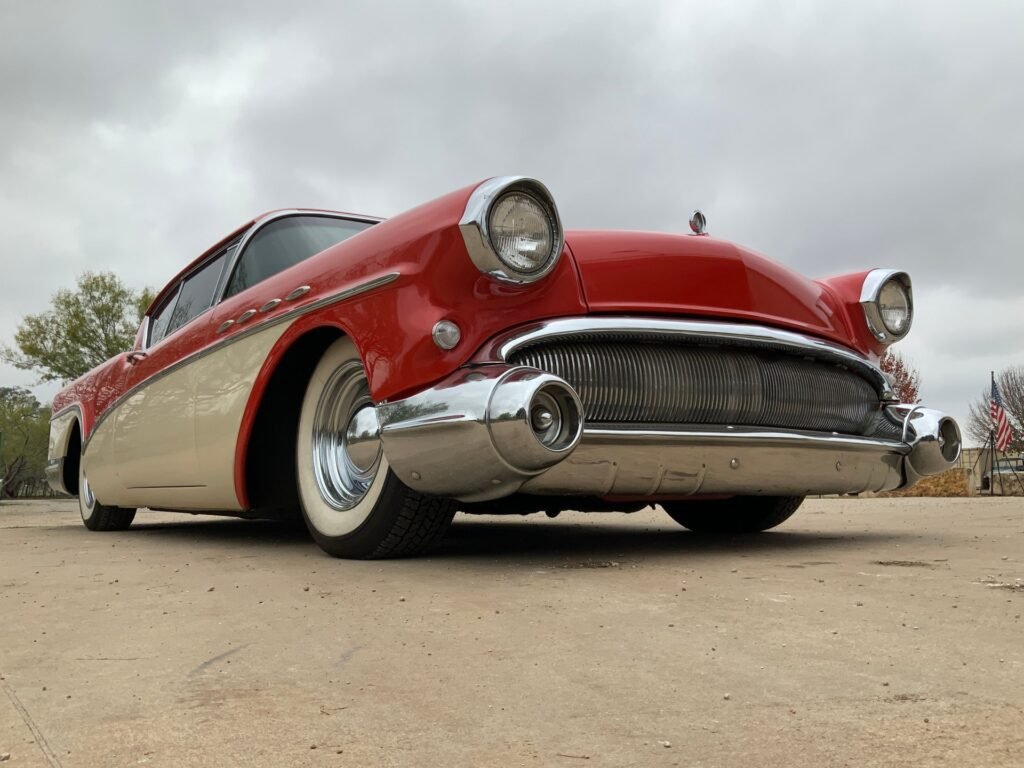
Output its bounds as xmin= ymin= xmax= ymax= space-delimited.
xmin=83 ymin=323 xmax=291 ymax=511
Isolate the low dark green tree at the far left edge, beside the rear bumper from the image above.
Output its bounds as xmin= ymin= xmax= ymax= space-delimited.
xmin=0 ymin=387 xmax=50 ymax=498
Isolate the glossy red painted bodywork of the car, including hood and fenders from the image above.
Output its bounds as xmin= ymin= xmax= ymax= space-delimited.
xmin=53 ymin=178 xmax=884 ymax=514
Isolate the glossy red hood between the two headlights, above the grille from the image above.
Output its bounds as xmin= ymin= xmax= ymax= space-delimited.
xmin=565 ymin=230 xmax=850 ymax=343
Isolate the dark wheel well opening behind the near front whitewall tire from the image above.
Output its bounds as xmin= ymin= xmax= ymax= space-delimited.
xmin=244 ymin=328 xmax=343 ymax=516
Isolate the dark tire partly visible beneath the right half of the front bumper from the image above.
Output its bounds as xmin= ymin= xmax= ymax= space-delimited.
xmin=662 ymin=496 xmax=804 ymax=534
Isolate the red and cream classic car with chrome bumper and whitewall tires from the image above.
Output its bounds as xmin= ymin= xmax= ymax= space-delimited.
xmin=47 ymin=177 xmax=961 ymax=558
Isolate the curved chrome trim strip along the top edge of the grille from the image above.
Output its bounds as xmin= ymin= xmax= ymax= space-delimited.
xmin=484 ymin=316 xmax=895 ymax=401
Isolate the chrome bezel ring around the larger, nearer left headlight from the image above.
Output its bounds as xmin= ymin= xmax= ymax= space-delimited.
xmin=459 ymin=176 xmax=565 ymax=285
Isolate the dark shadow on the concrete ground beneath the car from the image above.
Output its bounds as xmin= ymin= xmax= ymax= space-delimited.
xmin=125 ymin=514 xmax=921 ymax=567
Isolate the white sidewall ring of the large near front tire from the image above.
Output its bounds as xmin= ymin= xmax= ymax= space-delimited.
xmin=296 ymin=339 xmax=390 ymax=538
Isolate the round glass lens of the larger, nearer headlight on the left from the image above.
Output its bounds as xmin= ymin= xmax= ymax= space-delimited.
xmin=487 ymin=190 xmax=557 ymax=274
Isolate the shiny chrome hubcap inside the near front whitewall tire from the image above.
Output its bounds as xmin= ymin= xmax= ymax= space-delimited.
xmin=312 ymin=360 xmax=381 ymax=512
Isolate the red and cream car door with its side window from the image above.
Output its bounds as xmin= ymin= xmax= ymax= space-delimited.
xmin=114 ymin=249 xmax=237 ymax=495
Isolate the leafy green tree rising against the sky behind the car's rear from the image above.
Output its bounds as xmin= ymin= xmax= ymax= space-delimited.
xmin=0 ymin=272 xmax=153 ymax=381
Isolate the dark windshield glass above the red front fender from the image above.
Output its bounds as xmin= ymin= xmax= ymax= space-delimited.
xmin=224 ymin=216 xmax=373 ymax=298
